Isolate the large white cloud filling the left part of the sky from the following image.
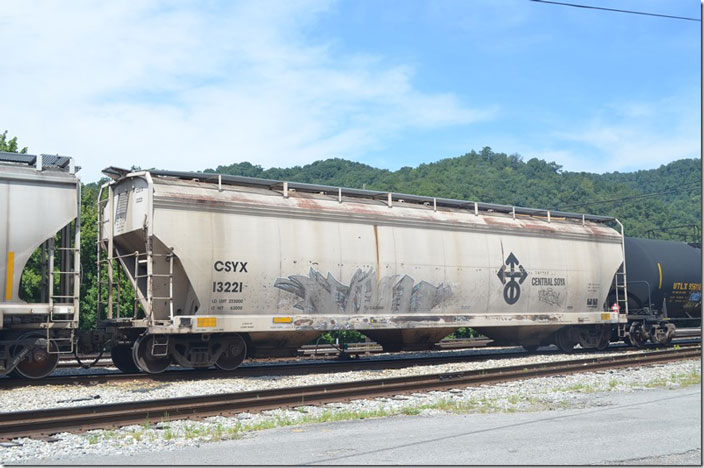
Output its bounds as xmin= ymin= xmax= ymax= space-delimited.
xmin=0 ymin=1 xmax=496 ymax=181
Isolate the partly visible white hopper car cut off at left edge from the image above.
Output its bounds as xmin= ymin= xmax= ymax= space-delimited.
xmin=0 ymin=152 xmax=81 ymax=378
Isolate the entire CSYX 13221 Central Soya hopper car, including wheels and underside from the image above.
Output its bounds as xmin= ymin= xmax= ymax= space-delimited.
xmin=99 ymin=168 xmax=625 ymax=372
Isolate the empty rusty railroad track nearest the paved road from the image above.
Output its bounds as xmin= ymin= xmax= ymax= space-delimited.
xmin=0 ymin=346 xmax=701 ymax=440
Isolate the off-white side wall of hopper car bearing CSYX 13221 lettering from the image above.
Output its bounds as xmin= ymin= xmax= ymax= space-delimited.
xmin=147 ymin=179 xmax=622 ymax=327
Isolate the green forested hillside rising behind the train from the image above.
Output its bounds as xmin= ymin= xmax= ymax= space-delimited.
xmin=206 ymin=148 xmax=701 ymax=240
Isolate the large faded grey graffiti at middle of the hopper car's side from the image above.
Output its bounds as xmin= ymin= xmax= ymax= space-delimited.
xmin=274 ymin=268 xmax=452 ymax=314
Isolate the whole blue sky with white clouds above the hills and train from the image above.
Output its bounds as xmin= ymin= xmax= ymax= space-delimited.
xmin=0 ymin=0 xmax=701 ymax=181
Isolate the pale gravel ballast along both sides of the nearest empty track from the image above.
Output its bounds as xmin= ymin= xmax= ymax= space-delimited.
xmin=0 ymin=353 xmax=701 ymax=464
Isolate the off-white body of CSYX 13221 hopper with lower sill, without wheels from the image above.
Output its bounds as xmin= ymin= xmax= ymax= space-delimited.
xmin=103 ymin=170 xmax=623 ymax=331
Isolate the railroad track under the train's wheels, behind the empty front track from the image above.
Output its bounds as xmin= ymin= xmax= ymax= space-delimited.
xmin=0 ymin=339 xmax=700 ymax=389
